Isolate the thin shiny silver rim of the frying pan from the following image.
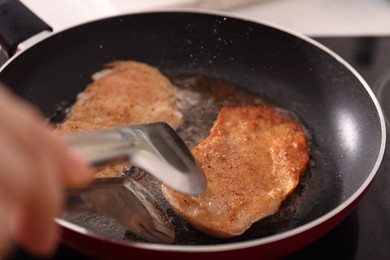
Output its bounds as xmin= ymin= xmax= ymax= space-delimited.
xmin=0 ymin=8 xmax=386 ymax=252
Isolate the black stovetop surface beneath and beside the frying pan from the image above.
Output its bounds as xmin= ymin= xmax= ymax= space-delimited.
xmin=8 ymin=36 xmax=390 ymax=260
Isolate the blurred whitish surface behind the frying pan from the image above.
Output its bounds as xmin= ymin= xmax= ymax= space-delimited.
xmin=21 ymin=0 xmax=390 ymax=36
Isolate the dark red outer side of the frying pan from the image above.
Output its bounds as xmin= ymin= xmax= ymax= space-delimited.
xmin=62 ymin=187 xmax=364 ymax=259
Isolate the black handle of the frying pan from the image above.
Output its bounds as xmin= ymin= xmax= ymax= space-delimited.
xmin=0 ymin=0 xmax=52 ymax=58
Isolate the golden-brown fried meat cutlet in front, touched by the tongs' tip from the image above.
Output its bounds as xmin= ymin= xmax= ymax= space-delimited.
xmin=162 ymin=106 xmax=309 ymax=238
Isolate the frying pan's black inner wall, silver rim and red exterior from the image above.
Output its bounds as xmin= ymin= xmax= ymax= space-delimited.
xmin=0 ymin=1 xmax=386 ymax=259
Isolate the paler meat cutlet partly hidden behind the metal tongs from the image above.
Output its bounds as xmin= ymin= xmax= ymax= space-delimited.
xmin=54 ymin=61 xmax=183 ymax=177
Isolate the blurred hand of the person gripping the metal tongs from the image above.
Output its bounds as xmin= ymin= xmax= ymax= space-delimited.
xmin=0 ymin=86 xmax=93 ymax=256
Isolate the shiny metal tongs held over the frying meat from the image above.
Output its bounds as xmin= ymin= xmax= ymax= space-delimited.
xmin=63 ymin=123 xmax=206 ymax=243
